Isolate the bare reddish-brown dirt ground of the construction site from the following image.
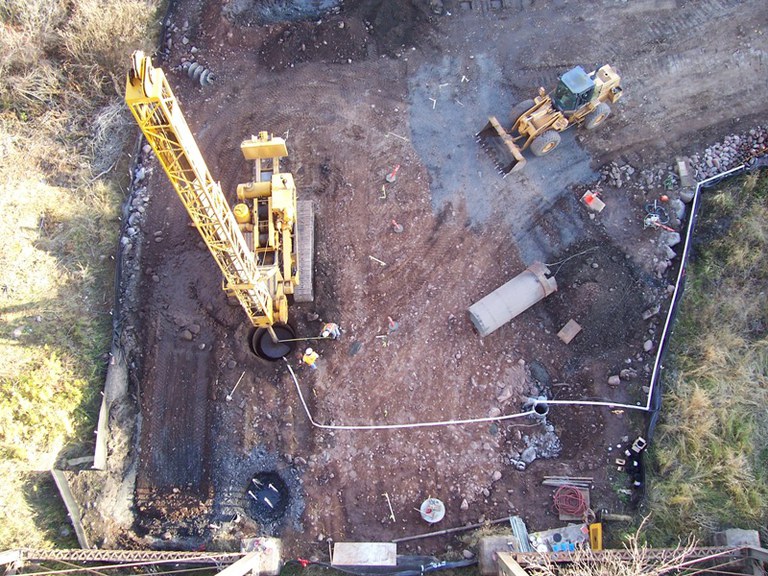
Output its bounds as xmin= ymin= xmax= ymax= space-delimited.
xmin=88 ymin=0 xmax=768 ymax=554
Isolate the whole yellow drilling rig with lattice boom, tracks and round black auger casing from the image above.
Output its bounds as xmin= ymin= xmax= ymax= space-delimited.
xmin=125 ymin=51 xmax=314 ymax=360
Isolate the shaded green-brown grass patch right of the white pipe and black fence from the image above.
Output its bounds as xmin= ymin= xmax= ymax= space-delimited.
xmin=648 ymin=174 xmax=768 ymax=545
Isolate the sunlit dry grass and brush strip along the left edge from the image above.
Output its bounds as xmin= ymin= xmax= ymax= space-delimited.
xmin=0 ymin=0 xmax=161 ymax=548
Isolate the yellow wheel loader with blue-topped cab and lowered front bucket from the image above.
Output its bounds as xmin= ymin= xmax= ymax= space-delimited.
xmin=477 ymin=64 xmax=622 ymax=176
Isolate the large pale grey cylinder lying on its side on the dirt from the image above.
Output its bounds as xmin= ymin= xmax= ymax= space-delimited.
xmin=469 ymin=262 xmax=557 ymax=336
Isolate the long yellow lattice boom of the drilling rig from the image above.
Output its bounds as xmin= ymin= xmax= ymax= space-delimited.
xmin=125 ymin=51 xmax=280 ymax=328
